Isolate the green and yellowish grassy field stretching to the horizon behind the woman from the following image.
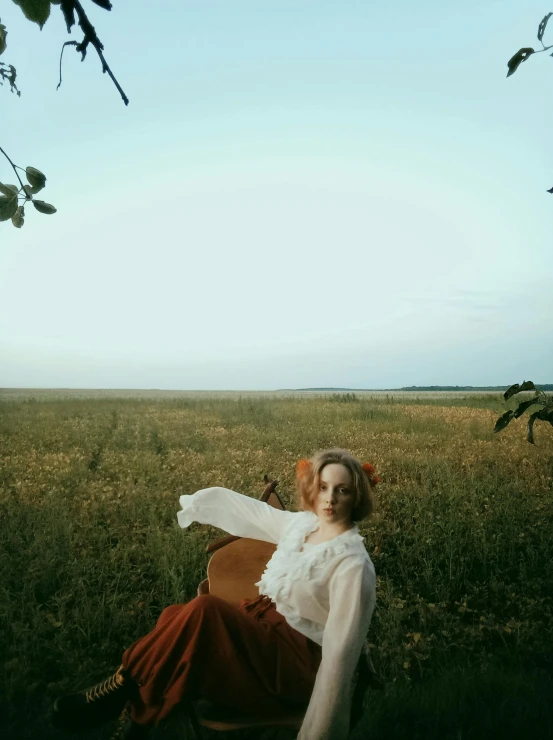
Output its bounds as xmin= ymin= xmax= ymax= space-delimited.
xmin=0 ymin=392 xmax=553 ymax=740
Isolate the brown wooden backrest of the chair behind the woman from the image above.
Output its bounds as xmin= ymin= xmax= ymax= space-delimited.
xmin=198 ymin=479 xmax=286 ymax=604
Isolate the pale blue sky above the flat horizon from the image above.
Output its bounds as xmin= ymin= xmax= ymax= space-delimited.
xmin=0 ymin=0 xmax=553 ymax=390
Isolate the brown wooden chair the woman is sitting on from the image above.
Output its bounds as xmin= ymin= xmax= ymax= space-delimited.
xmin=190 ymin=476 xmax=383 ymax=737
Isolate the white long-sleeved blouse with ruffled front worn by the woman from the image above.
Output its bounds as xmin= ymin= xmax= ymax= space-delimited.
xmin=177 ymin=487 xmax=376 ymax=740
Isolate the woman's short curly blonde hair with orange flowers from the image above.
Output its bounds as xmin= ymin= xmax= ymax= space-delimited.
xmin=296 ymin=447 xmax=375 ymax=522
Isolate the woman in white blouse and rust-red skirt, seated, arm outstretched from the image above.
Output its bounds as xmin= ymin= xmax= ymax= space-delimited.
xmin=54 ymin=449 xmax=380 ymax=740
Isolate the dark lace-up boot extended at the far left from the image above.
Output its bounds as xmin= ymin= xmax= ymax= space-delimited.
xmin=52 ymin=666 xmax=138 ymax=730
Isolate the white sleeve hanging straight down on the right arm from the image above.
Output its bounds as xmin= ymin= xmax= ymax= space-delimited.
xmin=297 ymin=558 xmax=376 ymax=740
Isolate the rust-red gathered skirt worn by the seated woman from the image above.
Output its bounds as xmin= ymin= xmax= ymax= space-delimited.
xmin=118 ymin=594 xmax=321 ymax=725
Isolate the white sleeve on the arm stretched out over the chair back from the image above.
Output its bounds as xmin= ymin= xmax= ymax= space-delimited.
xmin=177 ymin=486 xmax=297 ymax=545
